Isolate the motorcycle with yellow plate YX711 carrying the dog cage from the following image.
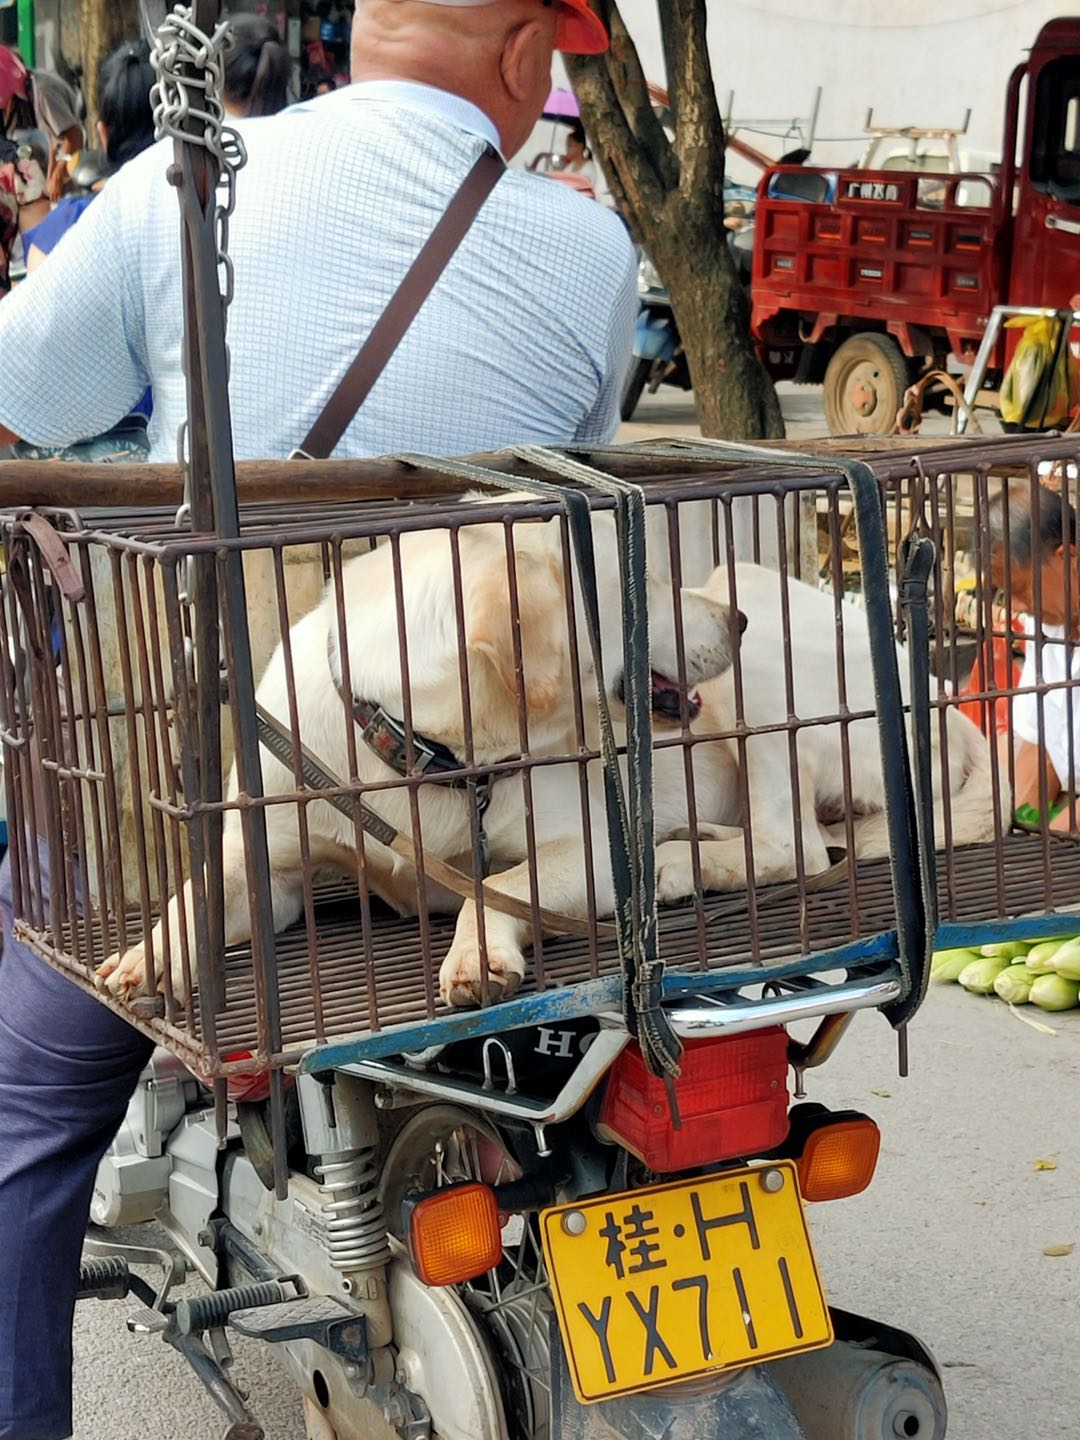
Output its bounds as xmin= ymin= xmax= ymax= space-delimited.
xmin=81 ymin=978 xmax=946 ymax=1440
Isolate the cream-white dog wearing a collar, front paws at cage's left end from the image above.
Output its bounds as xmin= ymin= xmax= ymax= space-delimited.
xmin=98 ymin=514 xmax=739 ymax=1005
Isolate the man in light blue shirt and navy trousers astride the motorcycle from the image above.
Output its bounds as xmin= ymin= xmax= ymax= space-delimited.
xmin=0 ymin=0 xmax=636 ymax=1440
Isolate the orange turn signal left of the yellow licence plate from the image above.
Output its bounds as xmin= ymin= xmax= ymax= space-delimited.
xmin=409 ymin=1184 xmax=503 ymax=1284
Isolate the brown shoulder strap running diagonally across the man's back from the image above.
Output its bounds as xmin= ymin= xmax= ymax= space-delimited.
xmin=289 ymin=145 xmax=505 ymax=459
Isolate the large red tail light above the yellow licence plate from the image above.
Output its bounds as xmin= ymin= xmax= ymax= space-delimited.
xmin=598 ymin=1027 xmax=788 ymax=1175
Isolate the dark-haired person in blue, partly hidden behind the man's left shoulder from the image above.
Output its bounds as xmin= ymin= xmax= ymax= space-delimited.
xmin=13 ymin=42 xmax=156 ymax=461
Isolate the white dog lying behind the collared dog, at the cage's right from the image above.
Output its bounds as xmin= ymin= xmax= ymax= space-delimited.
xmin=657 ymin=564 xmax=1008 ymax=901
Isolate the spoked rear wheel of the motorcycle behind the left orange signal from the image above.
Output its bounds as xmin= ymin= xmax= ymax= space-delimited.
xmin=382 ymin=1104 xmax=553 ymax=1440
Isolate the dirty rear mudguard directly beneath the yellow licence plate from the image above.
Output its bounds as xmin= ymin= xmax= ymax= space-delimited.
xmin=552 ymin=1318 xmax=806 ymax=1440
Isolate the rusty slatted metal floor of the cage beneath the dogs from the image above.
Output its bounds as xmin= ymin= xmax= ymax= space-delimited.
xmin=44 ymin=835 xmax=1080 ymax=1053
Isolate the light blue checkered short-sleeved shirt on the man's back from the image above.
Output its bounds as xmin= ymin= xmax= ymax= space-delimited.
xmin=0 ymin=81 xmax=636 ymax=459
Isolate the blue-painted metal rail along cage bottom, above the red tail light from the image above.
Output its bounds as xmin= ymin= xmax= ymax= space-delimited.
xmin=301 ymin=930 xmax=899 ymax=1073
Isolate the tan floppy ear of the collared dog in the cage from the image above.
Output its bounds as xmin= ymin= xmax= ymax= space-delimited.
xmin=468 ymin=547 xmax=569 ymax=714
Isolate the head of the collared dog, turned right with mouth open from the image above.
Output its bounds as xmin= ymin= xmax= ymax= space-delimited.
xmin=350 ymin=495 xmax=744 ymax=763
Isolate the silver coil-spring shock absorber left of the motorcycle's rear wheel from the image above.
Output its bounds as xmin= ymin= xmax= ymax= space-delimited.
xmin=297 ymin=1071 xmax=392 ymax=1349
